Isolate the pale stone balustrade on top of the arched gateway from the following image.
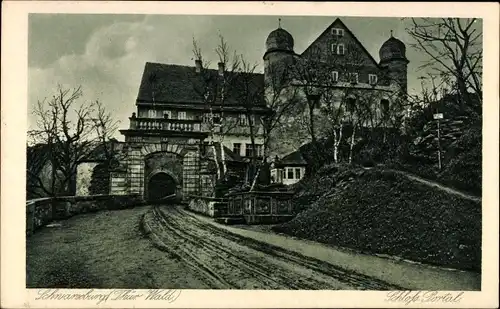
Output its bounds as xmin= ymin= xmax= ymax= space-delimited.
xmin=130 ymin=118 xmax=201 ymax=132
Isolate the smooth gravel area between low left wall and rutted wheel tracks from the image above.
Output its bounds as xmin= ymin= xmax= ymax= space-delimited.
xmin=26 ymin=207 xmax=208 ymax=289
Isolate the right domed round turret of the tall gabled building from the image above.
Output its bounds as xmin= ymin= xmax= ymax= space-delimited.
xmin=379 ymin=31 xmax=410 ymax=93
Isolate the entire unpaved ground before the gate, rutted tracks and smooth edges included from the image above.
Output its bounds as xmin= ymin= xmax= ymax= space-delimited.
xmin=27 ymin=206 xmax=480 ymax=290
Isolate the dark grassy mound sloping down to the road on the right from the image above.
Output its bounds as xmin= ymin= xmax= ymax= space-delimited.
xmin=273 ymin=167 xmax=481 ymax=270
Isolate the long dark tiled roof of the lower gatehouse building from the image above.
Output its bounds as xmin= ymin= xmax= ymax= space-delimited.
xmin=137 ymin=62 xmax=265 ymax=106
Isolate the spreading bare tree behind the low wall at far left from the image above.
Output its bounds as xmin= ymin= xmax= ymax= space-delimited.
xmin=27 ymin=86 xmax=116 ymax=196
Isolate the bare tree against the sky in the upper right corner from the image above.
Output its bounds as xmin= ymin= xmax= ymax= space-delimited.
xmin=407 ymin=18 xmax=483 ymax=116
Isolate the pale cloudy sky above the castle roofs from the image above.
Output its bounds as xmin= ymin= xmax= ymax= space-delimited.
xmin=28 ymin=14 xmax=450 ymax=140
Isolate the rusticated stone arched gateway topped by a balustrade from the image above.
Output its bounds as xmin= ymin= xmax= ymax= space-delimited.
xmin=111 ymin=115 xmax=207 ymax=199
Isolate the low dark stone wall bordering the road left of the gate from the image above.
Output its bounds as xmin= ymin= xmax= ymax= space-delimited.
xmin=26 ymin=194 xmax=144 ymax=236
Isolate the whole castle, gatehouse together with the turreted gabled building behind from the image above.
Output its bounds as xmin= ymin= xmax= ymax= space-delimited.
xmin=103 ymin=19 xmax=408 ymax=198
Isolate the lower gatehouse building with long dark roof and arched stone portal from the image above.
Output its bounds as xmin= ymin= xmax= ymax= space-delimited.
xmin=111 ymin=61 xmax=269 ymax=199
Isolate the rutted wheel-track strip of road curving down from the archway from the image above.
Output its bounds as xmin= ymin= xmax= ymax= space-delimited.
xmin=142 ymin=206 xmax=398 ymax=290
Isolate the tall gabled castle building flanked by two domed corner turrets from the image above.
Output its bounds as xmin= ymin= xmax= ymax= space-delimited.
xmin=263 ymin=19 xmax=409 ymax=157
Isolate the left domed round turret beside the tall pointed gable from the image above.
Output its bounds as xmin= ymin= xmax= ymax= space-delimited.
xmin=264 ymin=20 xmax=295 ymax=85
